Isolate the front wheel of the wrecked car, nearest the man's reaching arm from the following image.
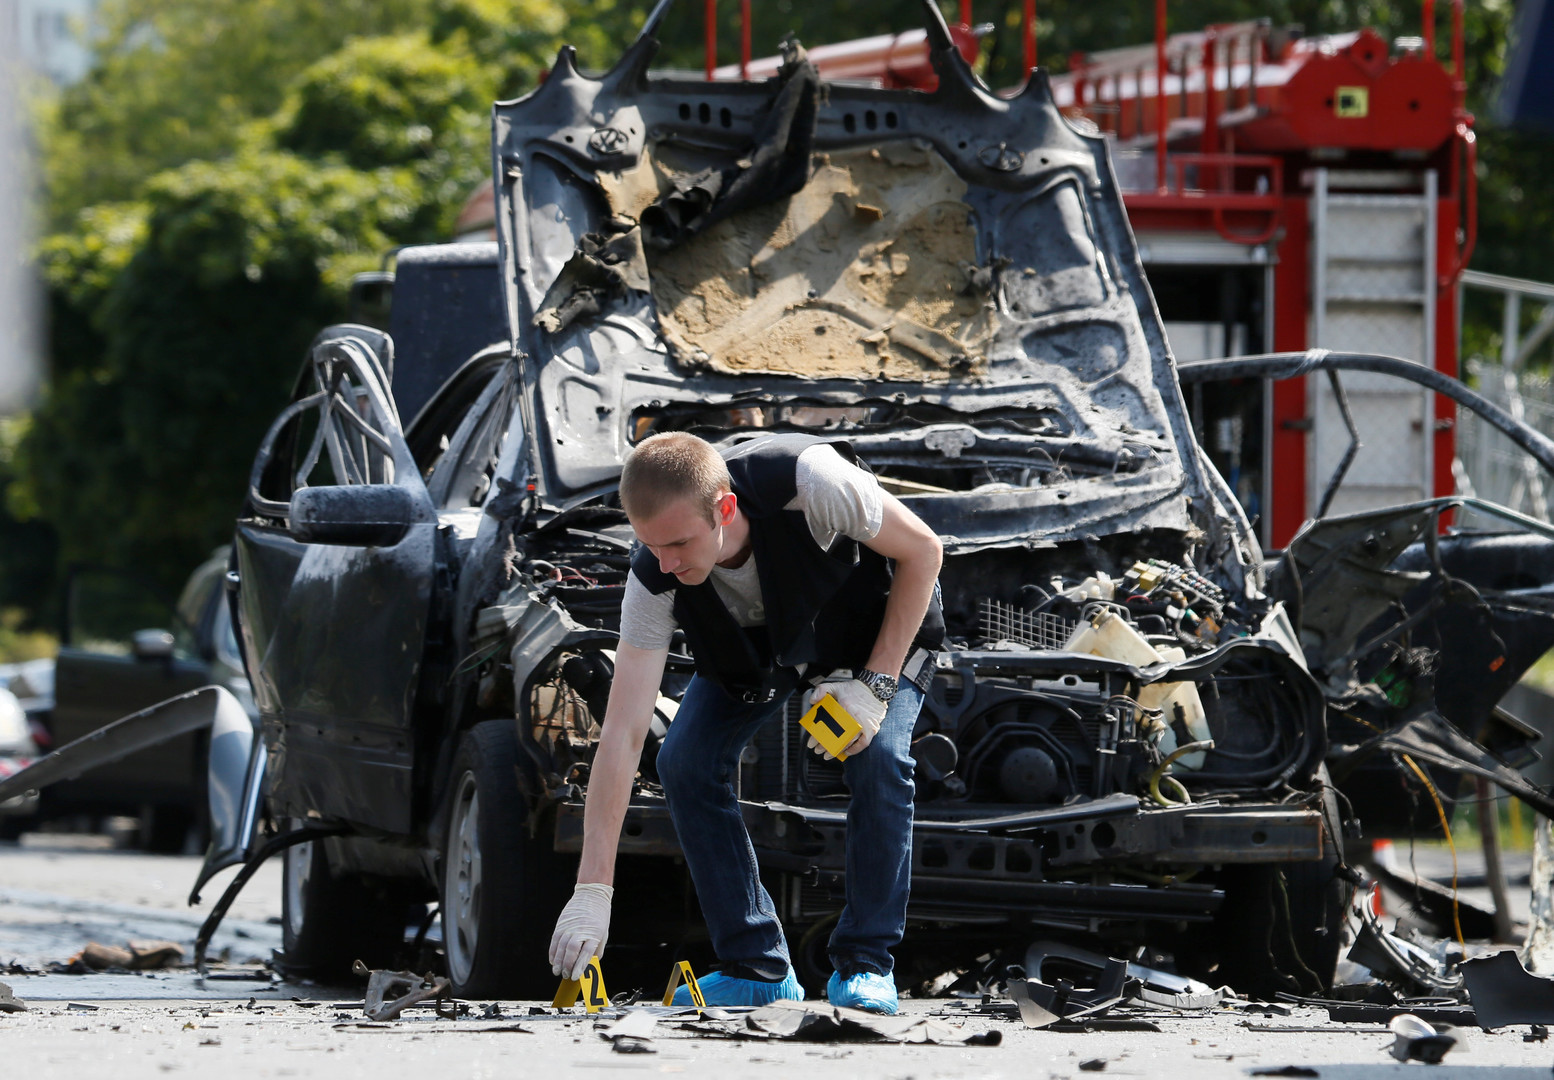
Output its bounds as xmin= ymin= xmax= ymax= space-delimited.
xmin=440 ymin=718 xmax=561 ymax=999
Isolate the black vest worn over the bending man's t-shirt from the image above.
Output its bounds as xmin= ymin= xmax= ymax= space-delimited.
xmin=631 ymin=435 xmax=945 ymax=701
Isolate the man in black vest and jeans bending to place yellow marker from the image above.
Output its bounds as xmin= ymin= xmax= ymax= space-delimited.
xmin=550 ymin=432 xmax=943 ymax=1013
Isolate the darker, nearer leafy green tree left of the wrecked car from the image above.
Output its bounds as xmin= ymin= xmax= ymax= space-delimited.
xmin=11 ymin=152 xmax=416 ymax=589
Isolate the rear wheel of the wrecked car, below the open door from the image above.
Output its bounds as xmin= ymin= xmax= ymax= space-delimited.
xmin=281 ymin=819 xmax=406 ymax=981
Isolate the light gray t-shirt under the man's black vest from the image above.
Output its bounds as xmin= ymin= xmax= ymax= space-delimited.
xmin=620 ymin=443 xmax=884 ymax=650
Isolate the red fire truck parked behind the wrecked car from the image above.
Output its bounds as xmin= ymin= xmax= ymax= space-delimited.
xmin=1052 ymin=0 xmax=1475 ymax=547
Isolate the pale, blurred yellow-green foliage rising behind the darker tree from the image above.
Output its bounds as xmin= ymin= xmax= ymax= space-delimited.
xmin=40 ymin=0 xmax=566 ymax=228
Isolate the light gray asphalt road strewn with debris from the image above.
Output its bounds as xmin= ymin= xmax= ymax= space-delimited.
xmin=0 ymin=838 xmax=1554 ymax=1080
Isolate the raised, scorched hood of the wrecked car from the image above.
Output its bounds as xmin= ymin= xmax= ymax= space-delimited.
xmin=493 ymin=5 xmax=1239 ymax=547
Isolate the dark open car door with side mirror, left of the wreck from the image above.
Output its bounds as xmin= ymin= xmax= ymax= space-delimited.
xmin=235 ymin=326 xmax=437 ymax=833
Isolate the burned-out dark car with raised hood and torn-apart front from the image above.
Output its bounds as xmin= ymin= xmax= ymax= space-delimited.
xmin=173 ymin=3 xmax=1554 ymax=996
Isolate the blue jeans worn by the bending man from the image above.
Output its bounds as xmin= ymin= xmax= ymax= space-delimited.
xmin=657 ymin=676 xmax=923 ymax=979
